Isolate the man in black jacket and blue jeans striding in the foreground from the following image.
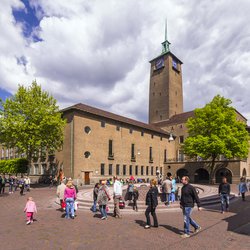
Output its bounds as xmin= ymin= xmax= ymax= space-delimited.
xmin=180 ymin=176 xmax=201 ymax=238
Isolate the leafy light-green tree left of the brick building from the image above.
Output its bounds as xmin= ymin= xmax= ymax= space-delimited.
xmin=0 ymin=81 xmax=65 ymax=174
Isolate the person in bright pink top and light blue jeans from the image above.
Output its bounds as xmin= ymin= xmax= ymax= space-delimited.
xmin=64 ymin=181 xmax=76 ymax=219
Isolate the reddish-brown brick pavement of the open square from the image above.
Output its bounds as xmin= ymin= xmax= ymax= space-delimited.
xmin=0 ymin=187 xmax=250 ymax=250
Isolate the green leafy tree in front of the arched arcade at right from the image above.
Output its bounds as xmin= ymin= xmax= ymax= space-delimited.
xmin=184 ymin=95 xmax=249 ymax=182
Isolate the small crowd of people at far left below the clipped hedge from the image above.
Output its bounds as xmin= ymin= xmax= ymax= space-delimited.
xmin=0 ymin=175 xmax=30 ymax=195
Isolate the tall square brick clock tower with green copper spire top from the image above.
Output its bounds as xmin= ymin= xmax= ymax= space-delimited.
xmin=149 ymin=26 xmax=183 ymax=123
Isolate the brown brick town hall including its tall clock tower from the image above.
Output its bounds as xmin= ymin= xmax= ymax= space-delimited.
xmin=1 ymin=30 xmax=250 ymax=184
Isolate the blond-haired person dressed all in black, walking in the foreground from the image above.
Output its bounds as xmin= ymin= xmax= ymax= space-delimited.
xmin=144 ymin=179 xmax=158 ymax=229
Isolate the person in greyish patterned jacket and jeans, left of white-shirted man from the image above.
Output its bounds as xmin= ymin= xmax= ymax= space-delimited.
xmin=97 ymin=180 xmax=110 ymax=220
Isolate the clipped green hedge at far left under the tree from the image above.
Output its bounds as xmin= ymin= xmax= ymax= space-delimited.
xmin=0 ymin=158 xmax=28 ymax=174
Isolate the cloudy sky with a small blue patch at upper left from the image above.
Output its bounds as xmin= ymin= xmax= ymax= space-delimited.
xmin=0 ymin=0 xmax=250 ymax=122
